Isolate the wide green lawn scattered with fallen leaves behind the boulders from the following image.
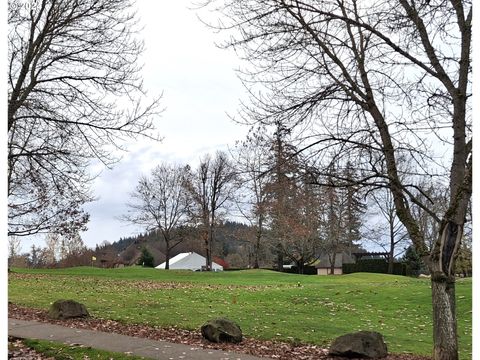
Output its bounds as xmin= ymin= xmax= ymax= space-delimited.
xmin=8 ymin=267 xmax=472 ymax=360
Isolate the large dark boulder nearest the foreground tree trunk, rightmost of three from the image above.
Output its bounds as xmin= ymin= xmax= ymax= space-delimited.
xmin=329 ymin=331 xmax=388 ymax=359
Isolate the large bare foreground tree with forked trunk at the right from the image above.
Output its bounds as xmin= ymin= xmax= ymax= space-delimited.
xmin=205 ymin=0 xmax=472 ymax=360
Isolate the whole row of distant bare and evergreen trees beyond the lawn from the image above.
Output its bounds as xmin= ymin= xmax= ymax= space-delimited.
xmin=122 ymin=127 xmax=365 ymax=272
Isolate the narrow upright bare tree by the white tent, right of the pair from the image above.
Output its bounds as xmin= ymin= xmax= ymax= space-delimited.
xmin=187 ymin=151 xmax=236 ymax=271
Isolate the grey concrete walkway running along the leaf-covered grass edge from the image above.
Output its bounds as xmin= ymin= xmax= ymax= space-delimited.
xmin=8 ymin=319 xmax=265 ymax=360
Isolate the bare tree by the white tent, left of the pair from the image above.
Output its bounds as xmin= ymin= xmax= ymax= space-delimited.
xmin=120 ymin=164 xmax=190 ymax=270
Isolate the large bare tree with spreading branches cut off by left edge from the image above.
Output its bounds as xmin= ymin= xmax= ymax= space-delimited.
xmin=7 ymin=0 xmax=158 ymax=239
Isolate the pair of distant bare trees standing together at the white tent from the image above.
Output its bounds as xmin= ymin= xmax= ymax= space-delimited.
xmin=121 ymin=152 xmax=235 ymax=269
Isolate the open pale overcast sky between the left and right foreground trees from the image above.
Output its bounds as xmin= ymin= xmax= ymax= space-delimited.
xmin=60 ymin=1 xmax=248 ymax=249
